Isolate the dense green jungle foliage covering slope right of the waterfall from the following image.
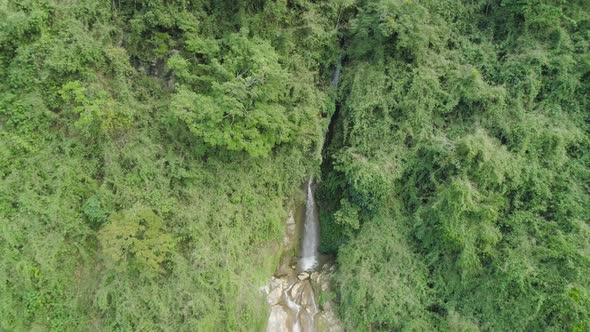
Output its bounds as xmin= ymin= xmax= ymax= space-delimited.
xmin=320 ymin=0 xmax=590 ymax=331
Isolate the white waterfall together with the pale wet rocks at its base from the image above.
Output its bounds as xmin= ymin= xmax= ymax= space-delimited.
xmin=260 ymin=178 xmax=344 ymax=332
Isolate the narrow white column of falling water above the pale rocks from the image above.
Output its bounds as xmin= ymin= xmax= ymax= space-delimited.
xmin=299 ymin=178 xmax=320 ymax=271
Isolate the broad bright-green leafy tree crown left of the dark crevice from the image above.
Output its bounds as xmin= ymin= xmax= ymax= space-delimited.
xmin=169 ymin=34 xmax=295 ymax=157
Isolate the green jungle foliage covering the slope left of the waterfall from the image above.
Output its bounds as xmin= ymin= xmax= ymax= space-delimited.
xmin=0 ymin=0 xmax=336 ymax=331
